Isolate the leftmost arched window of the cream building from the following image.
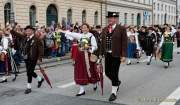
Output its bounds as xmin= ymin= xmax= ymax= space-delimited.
xmin=4 ymin=3 xmax=11 ymax=25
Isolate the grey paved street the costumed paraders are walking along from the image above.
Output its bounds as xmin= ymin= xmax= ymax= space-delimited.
xmin=0 ymin=50 xmax=180 ymax=105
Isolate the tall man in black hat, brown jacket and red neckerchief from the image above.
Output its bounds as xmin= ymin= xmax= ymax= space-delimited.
xmin=101 ymin=12 xmax=128 ymax=101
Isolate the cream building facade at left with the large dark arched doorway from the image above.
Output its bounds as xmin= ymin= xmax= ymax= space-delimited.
xmin=0 ymin=0 xmax=105 ymax=26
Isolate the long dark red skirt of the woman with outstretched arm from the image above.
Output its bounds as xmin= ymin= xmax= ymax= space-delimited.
xmin=74 ymin=50 xmax=100 ymax=85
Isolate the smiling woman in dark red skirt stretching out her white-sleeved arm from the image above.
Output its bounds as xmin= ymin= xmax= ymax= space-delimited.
xmin=61 ymin=23 xmax=99 ymax=96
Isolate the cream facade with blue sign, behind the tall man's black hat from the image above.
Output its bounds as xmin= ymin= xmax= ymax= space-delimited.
xmin=107 ymin=0 xmax=152 ymax=26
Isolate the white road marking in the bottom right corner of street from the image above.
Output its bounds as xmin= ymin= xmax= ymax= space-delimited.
xmin=159 ymin=87 xmax=180 ymax=105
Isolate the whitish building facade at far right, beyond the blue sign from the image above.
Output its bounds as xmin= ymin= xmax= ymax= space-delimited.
xmin=153 ymin=0 xmax=176 ymax=25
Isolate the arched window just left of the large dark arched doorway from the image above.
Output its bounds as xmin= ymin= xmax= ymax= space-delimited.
xmin=29 ymin=5 xmax=36 ymax=26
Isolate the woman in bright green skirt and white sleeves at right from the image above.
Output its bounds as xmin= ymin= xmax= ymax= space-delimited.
xmin=158 ymin=26 xmax=173 ymax=68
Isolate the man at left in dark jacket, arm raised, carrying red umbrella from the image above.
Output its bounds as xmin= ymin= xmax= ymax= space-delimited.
xmin=11 ymin=26 xmax=44 ymax=94
